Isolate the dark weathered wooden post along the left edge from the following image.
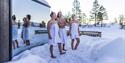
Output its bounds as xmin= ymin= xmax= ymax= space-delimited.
xmin=0 ymin=0 xmax=12 ymax=63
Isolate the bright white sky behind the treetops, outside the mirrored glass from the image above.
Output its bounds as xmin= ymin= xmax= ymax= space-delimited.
xmin=46 ymin=0 xmax=125 ymax=20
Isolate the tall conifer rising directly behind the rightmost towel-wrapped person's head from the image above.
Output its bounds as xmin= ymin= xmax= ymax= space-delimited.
xmin=72 ymin=0 xmax=82 ymax=21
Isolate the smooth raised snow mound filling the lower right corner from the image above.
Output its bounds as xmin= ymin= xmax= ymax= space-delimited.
xmin=96 ymin=38 xmax=125 ymax=63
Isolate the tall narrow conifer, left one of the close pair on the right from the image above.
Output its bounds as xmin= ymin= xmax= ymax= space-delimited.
xmin=90 ymin=0 xmax=100 ymax=26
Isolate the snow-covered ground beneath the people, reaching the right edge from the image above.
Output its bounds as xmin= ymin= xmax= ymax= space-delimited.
xmin=9 ymin=24 xmax=125 ymax=63
